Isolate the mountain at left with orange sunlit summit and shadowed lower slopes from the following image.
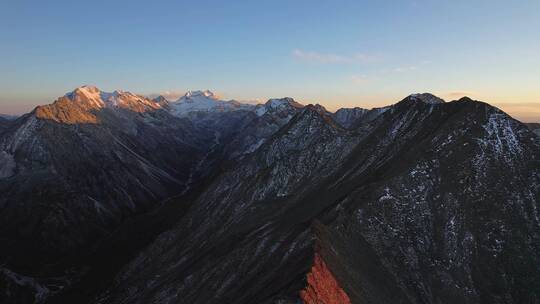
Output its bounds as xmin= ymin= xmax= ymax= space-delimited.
xmin=0 ymin=87 xmax=216 ymax=294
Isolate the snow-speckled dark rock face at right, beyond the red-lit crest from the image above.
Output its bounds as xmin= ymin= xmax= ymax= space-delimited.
xmin=320 ymin=101 xmax=540 ymax=303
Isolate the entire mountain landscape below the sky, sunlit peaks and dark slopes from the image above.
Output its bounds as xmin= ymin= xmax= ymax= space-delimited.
xmin=0 ymin=86 xmax=540 ymax=304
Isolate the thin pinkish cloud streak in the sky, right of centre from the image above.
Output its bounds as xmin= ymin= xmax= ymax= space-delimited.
xmin=292 ymin=49 xmax=379 ymax=64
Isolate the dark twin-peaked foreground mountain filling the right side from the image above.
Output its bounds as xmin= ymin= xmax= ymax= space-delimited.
xmin=78 ymin=95 xmax=540 ymax=303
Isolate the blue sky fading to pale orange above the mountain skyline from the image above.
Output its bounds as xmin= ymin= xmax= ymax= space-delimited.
xmin=0 ymin=0 xmax=540 ymax=120
